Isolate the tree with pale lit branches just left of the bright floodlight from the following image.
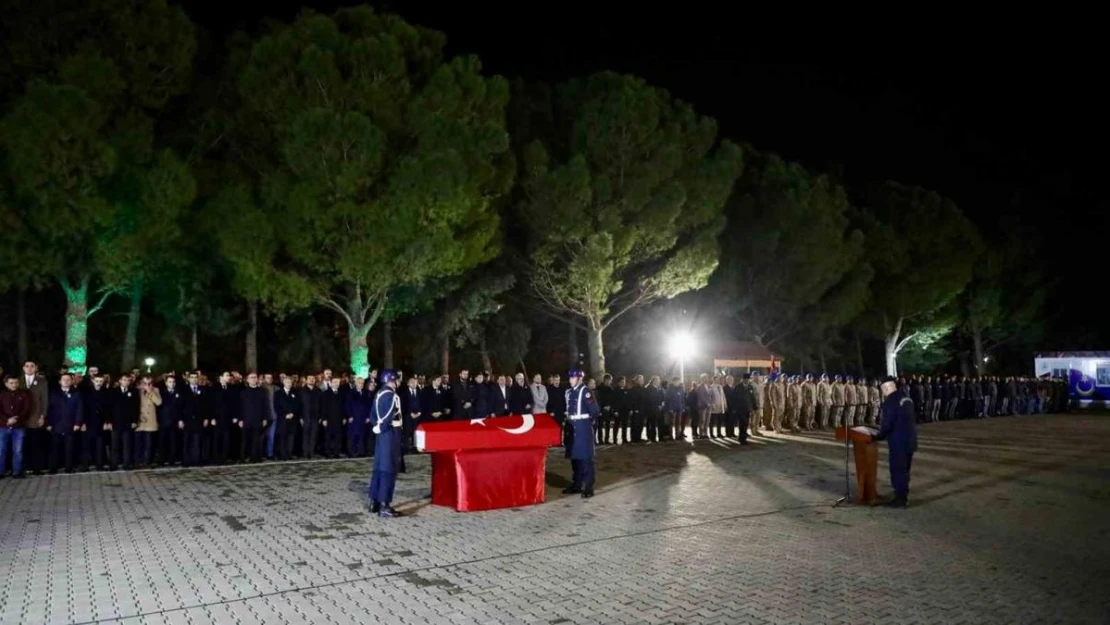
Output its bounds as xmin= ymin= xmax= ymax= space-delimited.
xmin=518 ymin=72 xmax=741 ymax=375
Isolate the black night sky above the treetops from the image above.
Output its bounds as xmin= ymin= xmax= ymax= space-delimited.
xmin=184 ymin=0 xmax=1110 ymax=349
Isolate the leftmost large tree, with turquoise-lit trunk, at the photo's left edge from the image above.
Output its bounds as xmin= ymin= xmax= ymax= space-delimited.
xmin=0 ymin=0 xmax=195 ymax=371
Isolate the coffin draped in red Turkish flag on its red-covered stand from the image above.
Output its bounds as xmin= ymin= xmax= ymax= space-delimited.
xmin=415 ymin=414 xmax=562 ymax=512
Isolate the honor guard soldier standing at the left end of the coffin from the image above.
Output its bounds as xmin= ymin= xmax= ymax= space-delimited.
xmin=370 ymin=370 xmax=403 ymax=518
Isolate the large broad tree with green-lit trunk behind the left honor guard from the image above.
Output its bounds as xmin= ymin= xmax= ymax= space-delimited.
xmin=225 ymin=7 xmax=512 ymax=372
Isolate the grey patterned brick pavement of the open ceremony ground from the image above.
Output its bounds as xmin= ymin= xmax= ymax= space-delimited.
xmin=0 ymin=415 xmax=1110 ymax=625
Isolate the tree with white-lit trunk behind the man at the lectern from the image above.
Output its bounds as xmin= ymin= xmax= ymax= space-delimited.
xmin=861 ymin=182 xmax=981 ymax=375
